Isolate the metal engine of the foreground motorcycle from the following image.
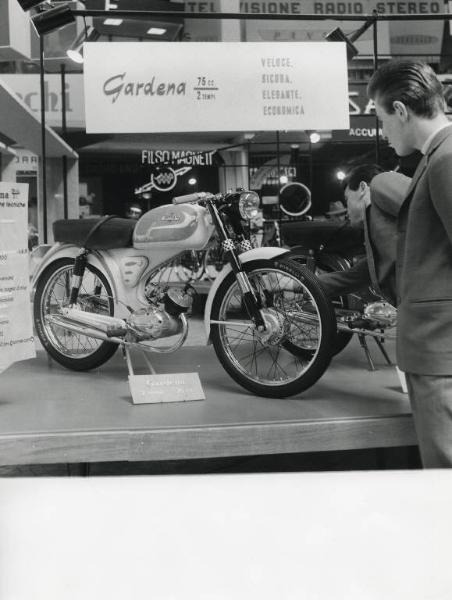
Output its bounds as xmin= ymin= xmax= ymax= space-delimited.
xmin=127 ymin=288 xmax=192 ymax=340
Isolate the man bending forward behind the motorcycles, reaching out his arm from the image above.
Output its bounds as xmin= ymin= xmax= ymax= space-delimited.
xmin=319 ymin=164 xmax=411 ymax=306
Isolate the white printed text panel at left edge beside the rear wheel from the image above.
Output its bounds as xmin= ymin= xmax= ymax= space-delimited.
xmin=0 ymin=182 xmax=36 ymax=373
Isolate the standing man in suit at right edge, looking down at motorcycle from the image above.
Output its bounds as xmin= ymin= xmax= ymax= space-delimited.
xmin=368 ymin=59 xmax=452 ymax=467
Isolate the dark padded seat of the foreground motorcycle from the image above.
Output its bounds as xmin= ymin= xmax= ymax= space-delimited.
xmin=53 ymin=217 xmax=136 ymax=250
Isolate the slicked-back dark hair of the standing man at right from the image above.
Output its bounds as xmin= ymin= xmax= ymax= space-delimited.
xmin=367 ymin=59 xmax=445 ymax=118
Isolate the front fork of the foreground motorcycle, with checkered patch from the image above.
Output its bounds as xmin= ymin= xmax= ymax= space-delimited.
xmin=207 ymin=201 xmax=266 ymax=331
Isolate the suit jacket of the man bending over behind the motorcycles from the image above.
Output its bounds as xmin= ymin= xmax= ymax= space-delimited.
xmin=319 ymin=172 xmax=411 ymax=306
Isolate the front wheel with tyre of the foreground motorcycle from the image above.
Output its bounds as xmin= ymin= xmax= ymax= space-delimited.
xmin=211 ymin=259 xmax=336 ymax=398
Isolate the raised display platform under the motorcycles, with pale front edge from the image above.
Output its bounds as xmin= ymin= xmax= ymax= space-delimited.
xmin=0 ymin=340 xmax=416 ymax=465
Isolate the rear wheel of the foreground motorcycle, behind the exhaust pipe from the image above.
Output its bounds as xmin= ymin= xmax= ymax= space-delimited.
xmin=33 ymin=258 xmax=118 ymax=371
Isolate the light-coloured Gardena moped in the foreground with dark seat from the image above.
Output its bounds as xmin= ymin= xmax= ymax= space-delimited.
xmin=32 ymin=190 xmax=336 ymax=398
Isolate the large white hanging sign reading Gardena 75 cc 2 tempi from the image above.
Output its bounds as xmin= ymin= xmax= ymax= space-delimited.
xmin=84 ymin=42 xmax=349 ymax=133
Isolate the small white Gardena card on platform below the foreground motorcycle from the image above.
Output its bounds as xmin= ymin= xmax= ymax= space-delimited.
xmin=129 ymin=373 xmax=206 ymax=404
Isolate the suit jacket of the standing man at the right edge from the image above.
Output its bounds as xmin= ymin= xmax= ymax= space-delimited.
xmin=396 ymin=127 xmax=452 ymax=375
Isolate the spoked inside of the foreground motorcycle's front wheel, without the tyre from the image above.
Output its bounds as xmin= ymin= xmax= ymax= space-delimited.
xmin=216 ymin=267 xmax=321 ymax=385
